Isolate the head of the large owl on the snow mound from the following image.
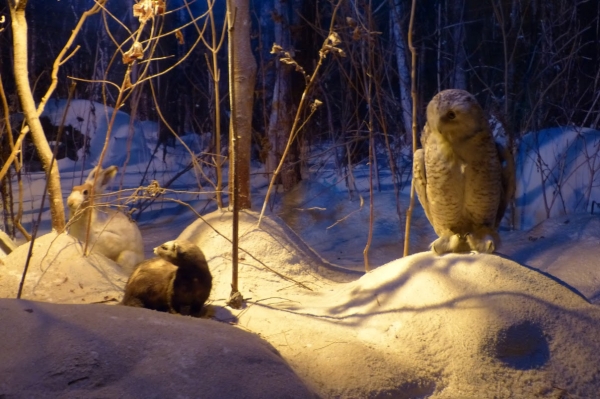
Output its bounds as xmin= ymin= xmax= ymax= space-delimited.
xmin=427 ymin=89 xmax=487 ymax=143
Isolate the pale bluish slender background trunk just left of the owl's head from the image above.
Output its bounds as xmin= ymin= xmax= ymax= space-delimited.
xmin=390 ymin=0 xmax=412 ymax=134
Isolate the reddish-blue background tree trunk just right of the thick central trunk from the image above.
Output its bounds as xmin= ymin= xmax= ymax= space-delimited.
xmin=266 ymin=0 xmax=300 ymax=191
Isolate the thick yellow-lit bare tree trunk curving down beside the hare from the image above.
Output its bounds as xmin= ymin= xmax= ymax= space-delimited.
xmin=9 ymin=0 xmax=65 ymax=232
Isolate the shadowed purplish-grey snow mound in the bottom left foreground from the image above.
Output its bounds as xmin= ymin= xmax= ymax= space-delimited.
xmin=0 ymin=299 xmax=314 ymax=399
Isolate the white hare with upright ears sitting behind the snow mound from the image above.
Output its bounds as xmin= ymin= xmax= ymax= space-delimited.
xmin=67 ymin=166 xmax=144 ymax=274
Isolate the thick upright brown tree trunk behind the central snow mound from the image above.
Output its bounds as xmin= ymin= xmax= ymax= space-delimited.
xmin=228 ymin=0 xmax=256 ymax=209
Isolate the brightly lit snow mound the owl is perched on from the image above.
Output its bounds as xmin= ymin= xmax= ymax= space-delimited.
xmin=180 ymin=212 xmax=600 ymax=399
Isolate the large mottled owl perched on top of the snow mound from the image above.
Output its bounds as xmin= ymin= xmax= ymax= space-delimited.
xmin=413 ymin=89 xmax=515 ymax=254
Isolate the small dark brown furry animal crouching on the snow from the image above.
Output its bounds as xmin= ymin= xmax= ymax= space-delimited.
xmin=121 ymin=240 xmax=212 ymax=317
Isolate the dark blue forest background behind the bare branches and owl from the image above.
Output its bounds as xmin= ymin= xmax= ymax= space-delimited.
xmin=0 ymin=0 xmax=600 ymax=189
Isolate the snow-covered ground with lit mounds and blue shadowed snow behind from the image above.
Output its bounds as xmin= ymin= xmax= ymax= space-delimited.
xmin=0 ymin=101 xmax=600 ymax=398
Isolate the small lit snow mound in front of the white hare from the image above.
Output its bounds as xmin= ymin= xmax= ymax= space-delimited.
xmin=0 ymin=232 xmax=128 ymax=303
